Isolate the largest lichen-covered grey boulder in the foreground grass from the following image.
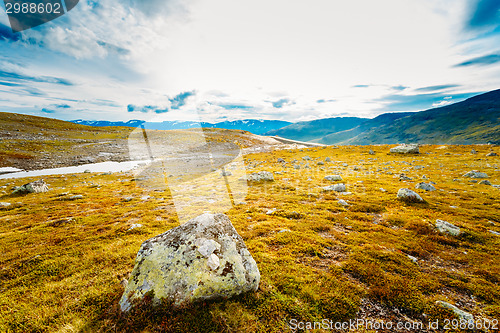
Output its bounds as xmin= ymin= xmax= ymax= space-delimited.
xmin=120 ymin=214 xmax=260 ymax=311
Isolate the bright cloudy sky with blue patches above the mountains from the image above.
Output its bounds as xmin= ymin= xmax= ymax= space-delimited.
xmin=0 ymin=0 xmax=500 ymax=122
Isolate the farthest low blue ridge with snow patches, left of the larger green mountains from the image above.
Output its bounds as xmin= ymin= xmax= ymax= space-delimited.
xmin=71 ymin=119 xmax=292 ymax=135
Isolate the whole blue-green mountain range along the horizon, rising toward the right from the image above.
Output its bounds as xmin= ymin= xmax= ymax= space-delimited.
xmin=73 ymin=89 xmax=500 ymax=145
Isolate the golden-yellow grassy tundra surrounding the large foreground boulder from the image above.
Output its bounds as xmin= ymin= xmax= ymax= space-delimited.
xmin=0 ymin=145 xmax=500 ymax=332
